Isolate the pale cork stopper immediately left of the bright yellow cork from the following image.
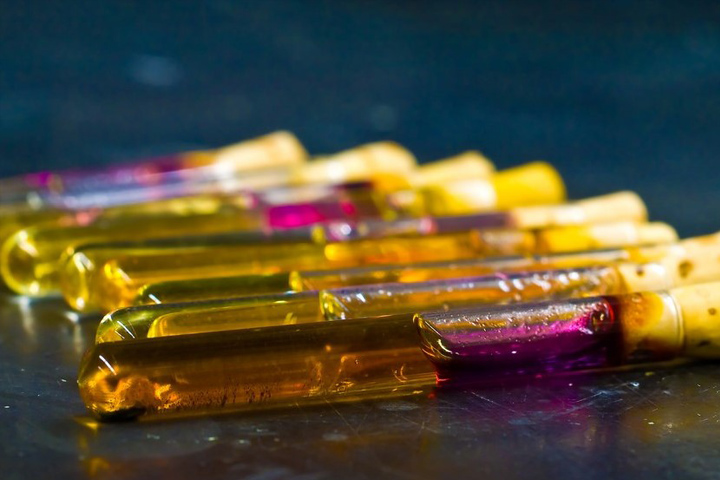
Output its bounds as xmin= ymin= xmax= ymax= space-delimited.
xmin=410 ymin=151 xmax=495 ymax=188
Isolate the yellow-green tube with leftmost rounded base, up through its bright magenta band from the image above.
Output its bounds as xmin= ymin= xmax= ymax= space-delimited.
xmin=0 ymin=183 xmax=383 ymax=296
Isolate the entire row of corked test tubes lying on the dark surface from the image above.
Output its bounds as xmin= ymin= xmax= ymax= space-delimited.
xmin=0 ymin=132 xmax=720 ymax=420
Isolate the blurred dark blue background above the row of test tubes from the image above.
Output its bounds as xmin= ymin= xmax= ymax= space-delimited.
xmin=0 ymin=0 xmax=720 ymax=235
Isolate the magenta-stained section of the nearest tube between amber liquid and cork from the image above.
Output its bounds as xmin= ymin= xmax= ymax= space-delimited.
xmin=419 ymin=297 xmax=625 ymax=380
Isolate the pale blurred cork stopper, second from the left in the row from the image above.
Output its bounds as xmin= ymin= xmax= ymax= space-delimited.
xmin=293 ymin=142 xmax=417 ymax=183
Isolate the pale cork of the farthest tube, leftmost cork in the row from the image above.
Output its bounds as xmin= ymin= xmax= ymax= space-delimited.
xmin=214 ymin=131 xmax=308 ymax=172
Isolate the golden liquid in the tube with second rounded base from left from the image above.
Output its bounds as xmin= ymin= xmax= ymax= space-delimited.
xmin=62 ymin=233 xmax=498 ymax=311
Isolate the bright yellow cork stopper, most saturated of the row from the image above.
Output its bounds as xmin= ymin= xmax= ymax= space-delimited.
xmin=492 ymin=162 xmax=565 ymax=210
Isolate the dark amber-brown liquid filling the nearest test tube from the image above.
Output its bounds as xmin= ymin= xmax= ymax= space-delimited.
xmin=78 ymin=316 xmax=435 ymax=420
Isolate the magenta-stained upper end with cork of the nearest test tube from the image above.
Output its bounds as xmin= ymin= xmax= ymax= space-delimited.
xmin=415 ymin=283 xmax=720 ymax=381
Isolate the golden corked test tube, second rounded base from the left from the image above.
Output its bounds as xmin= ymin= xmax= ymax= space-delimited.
xmin=61 ymin=222 xmax=677 ymax=311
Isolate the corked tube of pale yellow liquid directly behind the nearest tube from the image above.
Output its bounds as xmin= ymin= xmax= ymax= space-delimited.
xmin=97 ymin=235 xmax=720 ymax=342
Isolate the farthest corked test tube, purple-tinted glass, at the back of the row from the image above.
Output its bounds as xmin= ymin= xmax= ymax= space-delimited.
xmin=0 ymin=132 xmax=307 ymax=208
